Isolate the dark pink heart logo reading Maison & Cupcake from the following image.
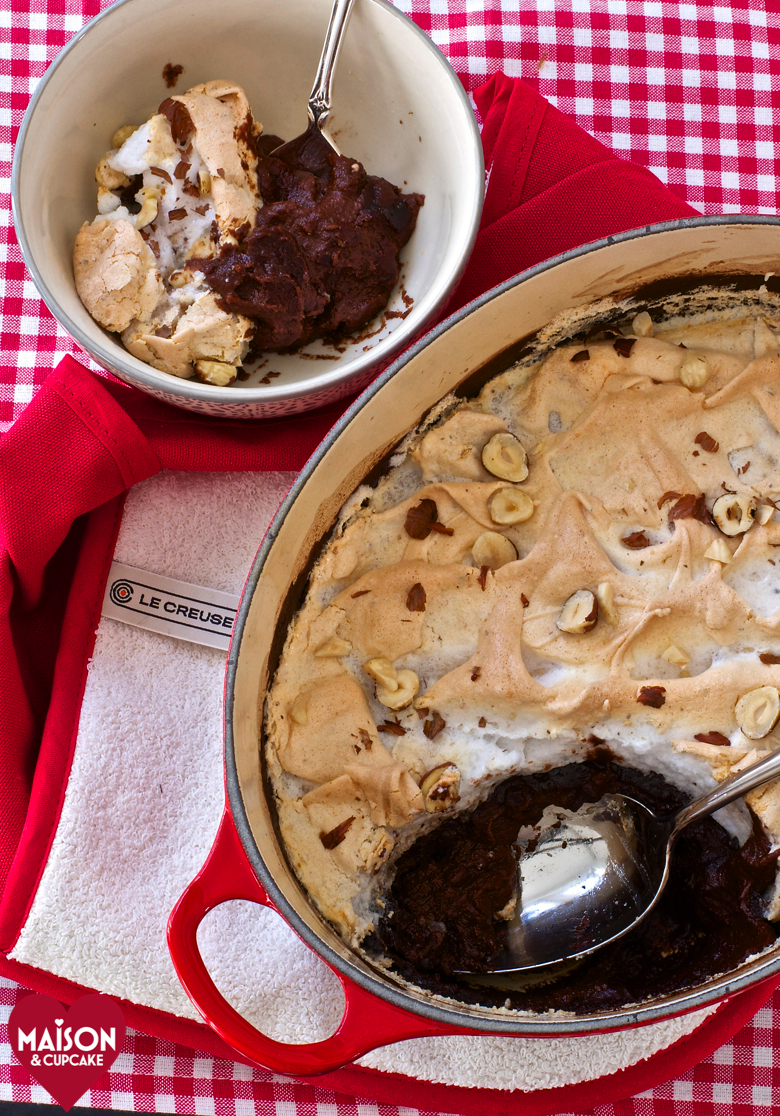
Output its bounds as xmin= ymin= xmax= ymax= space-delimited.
xmin=8 ymin=993 xmax=125 ymax=1112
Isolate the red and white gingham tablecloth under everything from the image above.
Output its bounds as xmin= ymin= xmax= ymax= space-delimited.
xmin=0 ymin=0 xmax=780 ymax=1116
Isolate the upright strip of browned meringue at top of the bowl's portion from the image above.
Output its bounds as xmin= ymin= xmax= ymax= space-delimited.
xmin=172 ymin=80 xmax=262 ymax=242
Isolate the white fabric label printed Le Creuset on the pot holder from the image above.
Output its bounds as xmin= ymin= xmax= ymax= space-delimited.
xmin=103 ymin=561 xmax=239 ymax=651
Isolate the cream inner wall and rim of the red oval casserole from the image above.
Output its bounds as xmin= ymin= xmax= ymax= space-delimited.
xmin=225 ymin=218 xmax=780 ymax=1035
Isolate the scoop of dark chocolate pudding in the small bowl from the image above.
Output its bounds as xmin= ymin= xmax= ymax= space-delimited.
xmin=195 ymin=129 xmax=424 ymax=353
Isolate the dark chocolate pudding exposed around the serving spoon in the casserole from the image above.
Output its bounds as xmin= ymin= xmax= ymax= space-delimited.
xmin=372 ymin=748 xmax=778 ymax=1012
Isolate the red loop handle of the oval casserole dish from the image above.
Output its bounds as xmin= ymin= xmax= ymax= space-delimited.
xmin=167 ymin=810 xmax=473 ymax=1077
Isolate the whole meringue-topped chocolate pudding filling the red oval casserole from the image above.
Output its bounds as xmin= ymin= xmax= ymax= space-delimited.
xmin=266 ymin=296 xmax=780 ymax=1011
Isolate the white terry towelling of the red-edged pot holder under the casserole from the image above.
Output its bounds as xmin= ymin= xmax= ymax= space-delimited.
xmin=11 ymin=472 xmax=714 ymax=1090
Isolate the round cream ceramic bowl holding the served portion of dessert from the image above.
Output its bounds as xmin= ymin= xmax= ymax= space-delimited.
xmin=12 ymin=0 xmax=484 ymax=419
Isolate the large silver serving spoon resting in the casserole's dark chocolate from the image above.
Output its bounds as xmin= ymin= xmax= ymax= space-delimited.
xmin=459 ymin=751 xmax=780 ymax=974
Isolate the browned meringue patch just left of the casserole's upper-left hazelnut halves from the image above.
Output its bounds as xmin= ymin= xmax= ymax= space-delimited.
xmin=412 ymin=410 xmax=508 ymax=481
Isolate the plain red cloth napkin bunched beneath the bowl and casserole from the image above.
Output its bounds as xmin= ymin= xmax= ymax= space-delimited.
xmin=0 ymin=75 xmax=695 ymax=968
